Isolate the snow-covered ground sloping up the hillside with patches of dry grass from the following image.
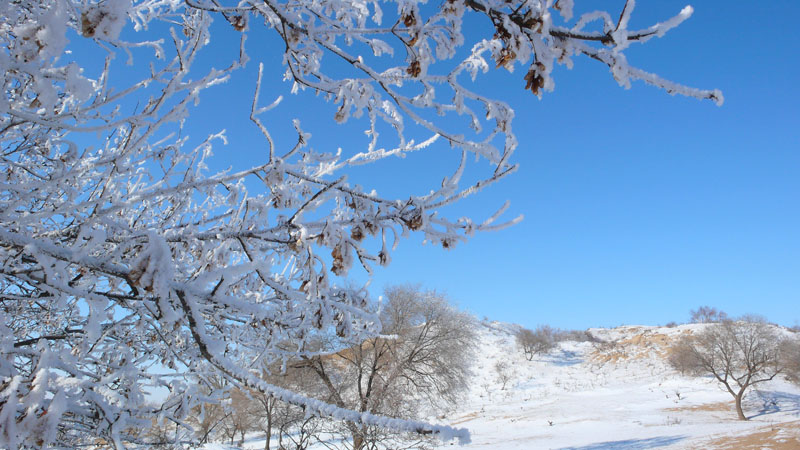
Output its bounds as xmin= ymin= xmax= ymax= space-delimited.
xmin=217 ymin=322 xmax=800 ymax=450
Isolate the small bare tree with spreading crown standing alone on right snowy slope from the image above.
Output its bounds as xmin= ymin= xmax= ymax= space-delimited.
xmin=670 ymin=317 xmax=785 ymax=420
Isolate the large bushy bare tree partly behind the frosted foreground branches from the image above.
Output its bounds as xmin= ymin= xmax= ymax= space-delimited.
xmin=297 ymin=286 xmax=476 ymax=450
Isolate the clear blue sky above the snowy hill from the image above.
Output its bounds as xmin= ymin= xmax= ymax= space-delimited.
xmin=95 ymin=0 xmax=800 ymax=328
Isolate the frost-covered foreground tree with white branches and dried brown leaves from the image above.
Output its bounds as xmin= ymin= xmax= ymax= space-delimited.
xmin=0 ymin=0 xmax=722 ymax=448
